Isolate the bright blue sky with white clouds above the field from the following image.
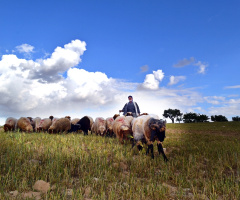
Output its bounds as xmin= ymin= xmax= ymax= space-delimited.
xmin=0 ymin=0 xmax=240 ymax=125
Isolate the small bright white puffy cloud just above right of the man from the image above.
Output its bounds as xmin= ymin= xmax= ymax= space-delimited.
xmin=139 ymin=69 xmax=164 ymax=90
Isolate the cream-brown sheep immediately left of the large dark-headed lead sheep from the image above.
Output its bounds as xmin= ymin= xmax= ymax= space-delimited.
xmin=113 ymin=116 xmax=133 ymax=144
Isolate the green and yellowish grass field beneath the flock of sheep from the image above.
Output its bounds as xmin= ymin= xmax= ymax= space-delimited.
xmin=0 ymin=122 xmax=240 ymax=200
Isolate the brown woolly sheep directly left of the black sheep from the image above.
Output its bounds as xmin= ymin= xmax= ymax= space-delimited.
xmin=48 ymin=118 xmax=71 ymax=133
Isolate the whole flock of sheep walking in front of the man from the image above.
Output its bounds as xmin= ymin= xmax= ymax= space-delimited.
xmin=4 ymin=113 xmax=168 ymax=162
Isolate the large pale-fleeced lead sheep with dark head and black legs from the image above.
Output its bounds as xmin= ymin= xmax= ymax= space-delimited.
xmin=132 ymin=115 xmax=168 ymax=162
